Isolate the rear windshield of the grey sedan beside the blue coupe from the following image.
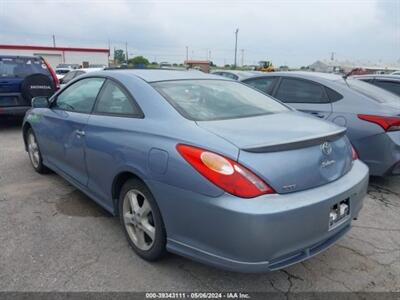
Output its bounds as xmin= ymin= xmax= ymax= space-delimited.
xmin=346 ymin=78 xmax=400 ymax=105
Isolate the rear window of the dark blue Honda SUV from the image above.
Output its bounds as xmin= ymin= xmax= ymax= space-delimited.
xmin=0 ymin=57 xmax=50 ymax=78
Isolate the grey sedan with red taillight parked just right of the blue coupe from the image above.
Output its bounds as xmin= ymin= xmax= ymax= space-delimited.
xmin=239 ymin=72 xmax=400 ymax=176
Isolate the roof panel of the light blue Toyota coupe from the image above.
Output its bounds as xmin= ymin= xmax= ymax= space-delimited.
xmin=101 ymin=69 xmax=229 ymax=82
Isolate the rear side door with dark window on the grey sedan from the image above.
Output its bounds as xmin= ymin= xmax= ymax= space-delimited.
xmin=272 ymin=77 xmax=332 ymax=119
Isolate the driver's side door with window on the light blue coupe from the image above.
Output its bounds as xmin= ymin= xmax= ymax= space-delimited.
xmin=39 ymin=78 xmax=105 ymax=185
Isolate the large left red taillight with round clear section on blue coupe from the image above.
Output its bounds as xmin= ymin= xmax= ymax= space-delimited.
xmin=176 ymin=144 xmax=275 ymax=198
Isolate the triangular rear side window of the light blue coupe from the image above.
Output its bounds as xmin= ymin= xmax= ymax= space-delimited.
xmin=94 ymin=80 xmax=141 ymax=116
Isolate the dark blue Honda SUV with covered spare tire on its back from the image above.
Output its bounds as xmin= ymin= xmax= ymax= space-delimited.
xmin=0 ymin=55 xmax=59 ymax=116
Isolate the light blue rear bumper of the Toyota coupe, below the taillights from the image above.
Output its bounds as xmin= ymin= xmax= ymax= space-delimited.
xmin=148 ymin=161 xmax=369 ymax=272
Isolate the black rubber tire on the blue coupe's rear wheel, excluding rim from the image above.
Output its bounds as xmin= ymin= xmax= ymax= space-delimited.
xmin=118 ymin=178 xmax=167 ymax=261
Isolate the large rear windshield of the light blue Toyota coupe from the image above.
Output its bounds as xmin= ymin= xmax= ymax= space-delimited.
xmin=153 ymin=80 xmax=289 ymax=121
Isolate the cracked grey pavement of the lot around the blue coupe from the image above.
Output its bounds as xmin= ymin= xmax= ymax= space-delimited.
xmin=0 ymin=121 xmax=400 ymax=293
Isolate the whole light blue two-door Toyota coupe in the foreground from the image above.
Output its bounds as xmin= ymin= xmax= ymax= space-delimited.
xmin=23 ymin=70 xmax=368 ymax=272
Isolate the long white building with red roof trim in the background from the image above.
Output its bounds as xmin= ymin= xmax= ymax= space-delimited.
xmin=0 ymin=44 xmax=110 ymax=68
